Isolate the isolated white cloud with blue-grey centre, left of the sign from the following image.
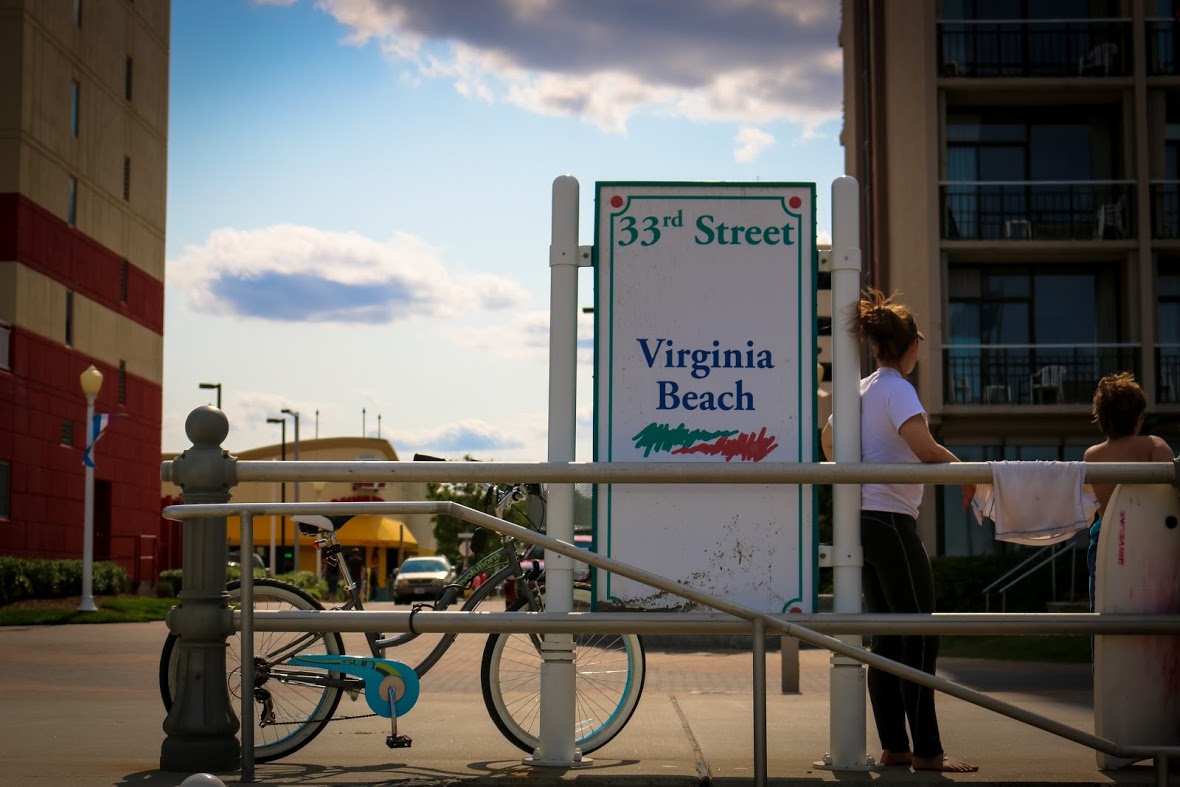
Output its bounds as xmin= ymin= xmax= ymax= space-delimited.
xmin=168 ymin=224 xmax=527 ymax=323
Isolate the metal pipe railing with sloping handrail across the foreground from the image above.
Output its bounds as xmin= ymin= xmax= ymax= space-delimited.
xmin=162 ymin=455 xmax=1180 ymax=786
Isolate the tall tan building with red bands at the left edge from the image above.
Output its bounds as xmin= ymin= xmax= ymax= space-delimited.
xmin=0 ymin=0 xmax=171 ymax=582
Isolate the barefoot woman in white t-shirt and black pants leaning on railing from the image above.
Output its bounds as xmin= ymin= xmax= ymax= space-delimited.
xmin=822 ymin=288 xmax=979 ymax=773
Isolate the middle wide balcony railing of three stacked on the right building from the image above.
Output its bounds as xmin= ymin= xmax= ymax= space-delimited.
xmin=939 ymin=181 xmax=1135 ymax=241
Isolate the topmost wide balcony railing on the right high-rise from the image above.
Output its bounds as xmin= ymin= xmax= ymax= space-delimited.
xmin=938 ymin=19 xmax=1130 ymax=78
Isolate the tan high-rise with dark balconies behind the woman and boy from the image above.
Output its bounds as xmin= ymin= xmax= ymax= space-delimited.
xmin=840 ymin=0 xmax=1180 ymax=555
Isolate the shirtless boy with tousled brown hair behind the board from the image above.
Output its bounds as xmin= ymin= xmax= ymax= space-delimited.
xmin=1083 ymin=372 xmax=1173 ymax=612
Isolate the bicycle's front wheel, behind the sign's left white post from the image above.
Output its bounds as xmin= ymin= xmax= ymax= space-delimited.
xmin=480 ymin=588 xmax=647 ymax=754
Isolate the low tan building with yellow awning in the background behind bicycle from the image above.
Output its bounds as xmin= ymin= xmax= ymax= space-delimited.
xmin=160 ymin=437 xmax=437 ymax=586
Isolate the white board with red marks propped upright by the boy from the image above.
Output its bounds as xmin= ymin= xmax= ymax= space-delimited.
xmin=1094 ymin=484 xmax=1180 ymax=770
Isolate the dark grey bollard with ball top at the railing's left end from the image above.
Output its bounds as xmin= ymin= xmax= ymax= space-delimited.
xmin=159 ymin=406 xmax=242 ymax=773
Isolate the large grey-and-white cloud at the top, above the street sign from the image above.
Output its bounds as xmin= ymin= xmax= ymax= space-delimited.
xmin=316 ymin=0 xmax=843 ymax=136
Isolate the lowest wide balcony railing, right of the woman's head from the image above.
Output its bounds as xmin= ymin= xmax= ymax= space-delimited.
xmin=943 ymin=343 xmax=1132 ymax=405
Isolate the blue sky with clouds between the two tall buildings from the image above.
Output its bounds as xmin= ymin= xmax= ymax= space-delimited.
xmin=162 ymin=0 xmax=844 ymax=461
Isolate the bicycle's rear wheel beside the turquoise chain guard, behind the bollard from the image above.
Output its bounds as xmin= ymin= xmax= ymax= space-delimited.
xmin=159 ymin=578 xmax=345 ymax=762
